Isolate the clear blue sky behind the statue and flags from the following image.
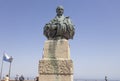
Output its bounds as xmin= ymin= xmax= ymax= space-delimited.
xmin=0 ymin=0 xmax=120 ymax=79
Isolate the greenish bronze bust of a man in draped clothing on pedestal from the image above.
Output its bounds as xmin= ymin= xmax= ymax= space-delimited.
xmin=44 ymin=6 xmax=75 ymax=40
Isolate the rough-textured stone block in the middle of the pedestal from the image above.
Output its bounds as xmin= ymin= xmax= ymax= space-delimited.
xmin=39 ymin=60 xmax=73 ymax=75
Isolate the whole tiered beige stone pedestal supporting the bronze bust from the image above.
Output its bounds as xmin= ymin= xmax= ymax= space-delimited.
xmin=39 ymin=39 xmax=73 ymax=81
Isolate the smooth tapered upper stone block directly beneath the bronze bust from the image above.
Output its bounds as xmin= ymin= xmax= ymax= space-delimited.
xmin=43 ymin=39 xmax=70 ymax=59
